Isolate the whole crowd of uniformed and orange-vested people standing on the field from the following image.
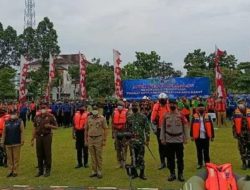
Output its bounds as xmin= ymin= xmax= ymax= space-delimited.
xmin=0 ymin=93 xmax=250 ymax=186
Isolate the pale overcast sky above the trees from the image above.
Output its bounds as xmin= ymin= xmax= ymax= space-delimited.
xmin=0 ymin=0 xmax=250 ymax=70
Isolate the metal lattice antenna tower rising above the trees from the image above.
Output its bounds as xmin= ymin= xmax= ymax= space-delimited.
xmin=24 ymin=0 xmax=36 ymax=29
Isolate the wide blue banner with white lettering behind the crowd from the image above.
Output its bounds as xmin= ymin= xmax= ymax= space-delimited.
xmin=123 ymin=77 xmax=210 ymax=100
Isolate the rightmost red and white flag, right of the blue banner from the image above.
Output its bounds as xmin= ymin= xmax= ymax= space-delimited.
xmin=214 ymin=48 xmax=227 ymax=98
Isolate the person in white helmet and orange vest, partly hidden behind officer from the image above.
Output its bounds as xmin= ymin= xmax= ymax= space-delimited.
xmin=151 ymin=93 xmax=169 ymax=170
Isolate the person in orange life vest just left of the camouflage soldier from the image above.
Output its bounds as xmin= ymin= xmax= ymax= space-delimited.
xmin=112 ymin=101 xmax=128 ymax=168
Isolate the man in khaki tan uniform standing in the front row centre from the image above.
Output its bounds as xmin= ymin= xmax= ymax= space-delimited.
xmin=85 ymin=105 xmax=108 ymax=179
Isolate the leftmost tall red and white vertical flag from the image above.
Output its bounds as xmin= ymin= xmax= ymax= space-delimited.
xmin=19 ymin=56 xmax=29 ymax=102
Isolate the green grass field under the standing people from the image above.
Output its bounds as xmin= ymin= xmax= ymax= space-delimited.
xmin=0 ymin=123 xmax=249 ymax=189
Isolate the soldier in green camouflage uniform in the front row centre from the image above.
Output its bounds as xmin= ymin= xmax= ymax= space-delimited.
xmin=126 ymin=102 xmax=150 ymax=180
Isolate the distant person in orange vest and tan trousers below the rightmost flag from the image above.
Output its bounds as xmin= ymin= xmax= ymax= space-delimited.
xmin=215 ymin=96 xmax=226 ymax=127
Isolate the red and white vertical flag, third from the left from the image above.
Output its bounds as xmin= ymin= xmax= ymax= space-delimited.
xmin=79 ymin=53 xmax=87 ymax=100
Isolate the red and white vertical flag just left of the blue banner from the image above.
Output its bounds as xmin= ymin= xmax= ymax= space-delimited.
xmin=113 ymin=49 xmax=123 ymax=98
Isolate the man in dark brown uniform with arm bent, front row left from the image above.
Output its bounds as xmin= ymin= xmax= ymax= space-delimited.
xmin=31 ymin=103 xmax=57 ymax=177
